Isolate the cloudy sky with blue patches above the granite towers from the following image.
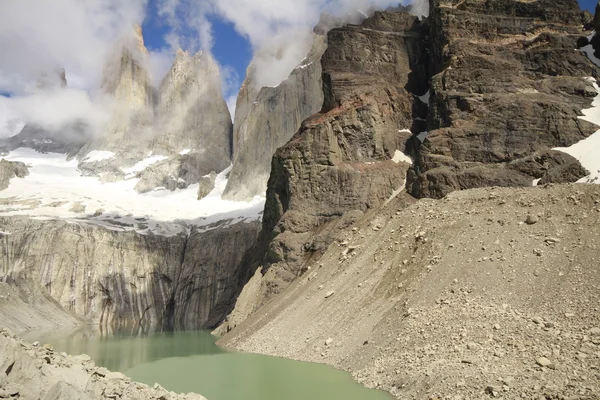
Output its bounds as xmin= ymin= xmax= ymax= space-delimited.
xmin=0 ymin=0 xmax=428 ymax=135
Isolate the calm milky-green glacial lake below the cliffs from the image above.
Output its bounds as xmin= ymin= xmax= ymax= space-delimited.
xmin=28 ymin=332 xmax=390 ymax=400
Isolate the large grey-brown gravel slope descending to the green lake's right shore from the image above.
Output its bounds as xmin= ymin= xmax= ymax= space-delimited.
xmin=220 ymin=185 xmax=600 ymax=399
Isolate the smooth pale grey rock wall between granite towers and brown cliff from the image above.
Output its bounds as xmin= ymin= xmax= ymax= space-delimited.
xmin=225 ymin=34 xmax=327 ymax=200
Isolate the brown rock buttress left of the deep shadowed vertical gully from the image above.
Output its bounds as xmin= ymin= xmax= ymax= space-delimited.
xmin=251 ymin=12 xmax=427 ymax=291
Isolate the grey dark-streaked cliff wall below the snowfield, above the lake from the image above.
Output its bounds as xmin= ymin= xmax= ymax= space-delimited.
xmin=0 ymin=217 xmax=259 ymax=329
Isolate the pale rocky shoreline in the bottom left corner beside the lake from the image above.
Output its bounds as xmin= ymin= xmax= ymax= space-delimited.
xmin=0 ymin=330 xmax=205 ymax=400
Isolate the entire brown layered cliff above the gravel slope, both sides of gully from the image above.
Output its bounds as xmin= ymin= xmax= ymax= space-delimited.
xmin=221 ymin=0 xmax=597 ymax=327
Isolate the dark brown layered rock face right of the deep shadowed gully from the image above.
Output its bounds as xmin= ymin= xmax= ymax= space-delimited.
xmin=409 ymin=0 xmax=597 ymax=197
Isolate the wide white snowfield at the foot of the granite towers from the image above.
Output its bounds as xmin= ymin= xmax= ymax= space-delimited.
xmin=0 ymin=148 xmax=265 ymax=236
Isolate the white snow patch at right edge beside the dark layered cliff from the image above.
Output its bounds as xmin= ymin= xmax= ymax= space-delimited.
xmin=554 ymin=78 xmax=600 ymax=183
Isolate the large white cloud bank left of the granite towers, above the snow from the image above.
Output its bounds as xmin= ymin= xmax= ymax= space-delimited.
xmin=0 ymin=0 xmax=147 ymax=136
